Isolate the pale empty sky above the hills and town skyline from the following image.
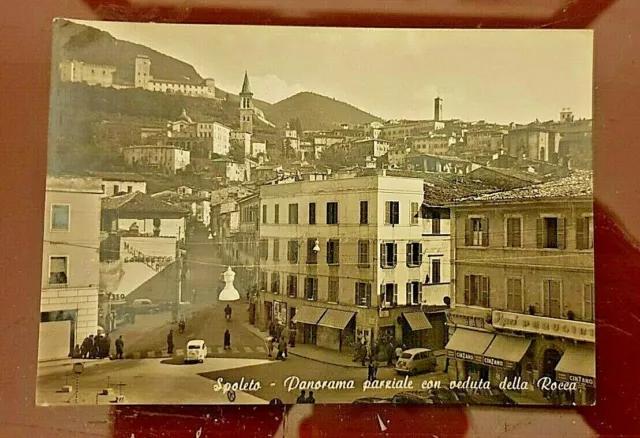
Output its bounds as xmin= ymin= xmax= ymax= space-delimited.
xmin=74 ymin=20 xmax=593 ymax=123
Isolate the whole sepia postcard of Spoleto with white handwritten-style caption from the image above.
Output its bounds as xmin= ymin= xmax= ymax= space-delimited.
xmin=36 ymin=19 xmax=596 ymax=404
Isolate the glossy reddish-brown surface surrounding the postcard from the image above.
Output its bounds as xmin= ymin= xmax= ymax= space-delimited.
xmin=0 ymin=0 xmax=640 ymax=438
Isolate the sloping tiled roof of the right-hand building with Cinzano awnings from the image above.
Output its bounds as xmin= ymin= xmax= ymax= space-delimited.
xmin=454 ymin=171 xmax=593 ymax=203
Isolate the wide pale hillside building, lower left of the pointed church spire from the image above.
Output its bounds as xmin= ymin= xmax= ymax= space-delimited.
xmin=124 ymin=145 xmax=191 ymax=175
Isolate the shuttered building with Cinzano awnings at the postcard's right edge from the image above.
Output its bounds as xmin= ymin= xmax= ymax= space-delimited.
xmin=446 ymin=171 xmax=595 ymax=404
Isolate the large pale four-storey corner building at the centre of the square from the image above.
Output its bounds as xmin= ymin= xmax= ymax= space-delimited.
xmin=258 ymin=171 xmax=438 ymax=351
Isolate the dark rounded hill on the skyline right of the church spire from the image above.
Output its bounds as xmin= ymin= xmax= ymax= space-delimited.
xmin=262 ymin=92 xmax=380 ymax=130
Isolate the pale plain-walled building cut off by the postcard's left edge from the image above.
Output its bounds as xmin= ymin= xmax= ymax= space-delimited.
xmin=38 ymin=177 xmax=102 ymax=361
